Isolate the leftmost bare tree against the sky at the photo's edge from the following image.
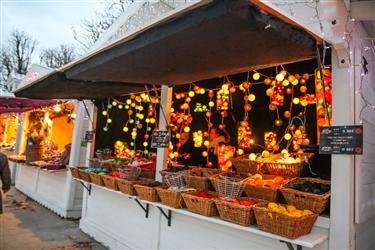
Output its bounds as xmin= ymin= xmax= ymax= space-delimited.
xmin=1 ymin=30 xmax=37 ymax=81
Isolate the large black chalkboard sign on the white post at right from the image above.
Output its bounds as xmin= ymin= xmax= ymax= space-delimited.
xmin=319 ymin=126 xmax=363 ymax=155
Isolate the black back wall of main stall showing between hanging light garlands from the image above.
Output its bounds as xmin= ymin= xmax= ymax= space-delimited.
xmin=95 ymin=58 xmax=331 ymax=179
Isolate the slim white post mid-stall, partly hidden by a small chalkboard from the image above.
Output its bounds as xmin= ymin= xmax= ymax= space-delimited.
xmin=155 ymin=85 xmax=173 ymax=181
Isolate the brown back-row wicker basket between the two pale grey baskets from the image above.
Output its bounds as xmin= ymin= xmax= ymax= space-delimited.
xmin=186 ymin=168 xmax=218 ymax=191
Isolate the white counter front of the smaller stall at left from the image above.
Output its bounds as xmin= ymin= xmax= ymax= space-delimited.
xmin=15 ymin=163 xmax=83 ymax=218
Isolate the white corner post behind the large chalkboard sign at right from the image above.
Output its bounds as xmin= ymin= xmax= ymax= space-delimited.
xmin=329 ymin=47 xmax=355 ymax=249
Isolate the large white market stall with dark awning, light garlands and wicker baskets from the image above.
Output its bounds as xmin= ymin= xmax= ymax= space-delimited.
xmin=16 ymin=0 xmax=373 ymax=249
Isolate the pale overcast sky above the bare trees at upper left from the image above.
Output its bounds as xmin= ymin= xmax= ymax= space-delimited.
xmin=0 ymin=0 xmax=102 ymax=52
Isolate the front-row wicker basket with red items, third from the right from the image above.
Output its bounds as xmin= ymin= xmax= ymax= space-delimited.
xmin=182 ymin=193 xmax=218 ymax=217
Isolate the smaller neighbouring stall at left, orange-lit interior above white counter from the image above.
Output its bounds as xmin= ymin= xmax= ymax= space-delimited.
xmin=9 ymin=101 xmax=87 ymax=218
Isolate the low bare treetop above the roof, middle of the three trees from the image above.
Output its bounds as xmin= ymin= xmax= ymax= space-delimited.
xmin=40 ymin=44 xmax=77 ymax=68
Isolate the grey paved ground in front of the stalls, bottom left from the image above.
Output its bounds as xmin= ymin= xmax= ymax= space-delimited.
xmin=0 ymin=187 xmax=105 ymax=250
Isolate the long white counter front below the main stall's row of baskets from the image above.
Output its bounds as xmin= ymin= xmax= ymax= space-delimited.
xmin=79 ymin=180 xmax=329 ymax=249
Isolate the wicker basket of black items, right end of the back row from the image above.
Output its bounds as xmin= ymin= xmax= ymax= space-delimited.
xmin=280 ymin=178 xmax=331 ymax=214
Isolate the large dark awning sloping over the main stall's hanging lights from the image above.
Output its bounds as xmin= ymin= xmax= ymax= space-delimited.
xmin=16 ymin=0 xmax=316 ymax=98
